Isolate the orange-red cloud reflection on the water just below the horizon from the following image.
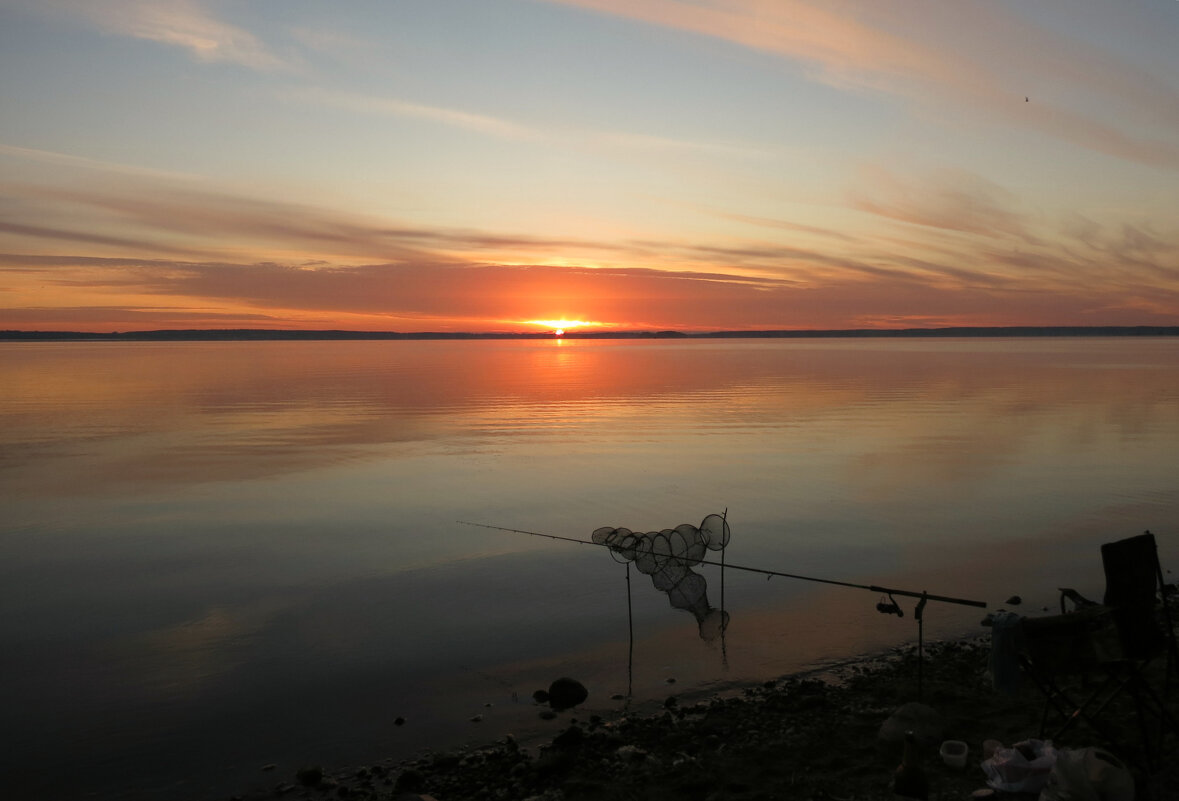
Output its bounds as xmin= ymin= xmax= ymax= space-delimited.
xmin=0 ymin=341 xmax=1174 ymax=494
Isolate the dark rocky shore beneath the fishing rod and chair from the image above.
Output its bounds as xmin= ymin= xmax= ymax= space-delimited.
xmin=236 ymin=637 xmax=1179 ymax=801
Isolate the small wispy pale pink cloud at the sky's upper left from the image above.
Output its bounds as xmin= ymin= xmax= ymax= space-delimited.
xmin=32 ymin=0 xmax=290 ymax=71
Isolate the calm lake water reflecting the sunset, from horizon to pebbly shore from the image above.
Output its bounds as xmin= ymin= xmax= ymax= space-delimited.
xmin=0 ymin=339 xmax=1179 ymax=800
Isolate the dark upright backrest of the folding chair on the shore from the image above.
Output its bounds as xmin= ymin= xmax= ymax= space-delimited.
xmin=1101 ymin=532 xmax=1164 ymax=659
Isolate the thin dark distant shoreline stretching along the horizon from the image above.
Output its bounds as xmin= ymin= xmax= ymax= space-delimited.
xmin=0 ymin=326 xmax=1179 ymax=342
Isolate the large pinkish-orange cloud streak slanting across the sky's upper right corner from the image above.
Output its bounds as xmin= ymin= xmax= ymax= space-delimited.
xmin=549 ymin=0 xmax=1179 ymax=169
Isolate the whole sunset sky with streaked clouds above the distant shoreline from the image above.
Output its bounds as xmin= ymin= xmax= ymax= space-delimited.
xmin=0 ymin=0 xmax=1179 ymax=331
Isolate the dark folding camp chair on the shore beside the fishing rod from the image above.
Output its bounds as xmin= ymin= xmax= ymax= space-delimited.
xmin=1019 ymin=532 xmax=1179 ymax=769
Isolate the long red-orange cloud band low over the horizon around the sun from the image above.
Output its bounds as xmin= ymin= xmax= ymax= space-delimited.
xmin=9 ymin=244 xmax=1179 ymax=330
